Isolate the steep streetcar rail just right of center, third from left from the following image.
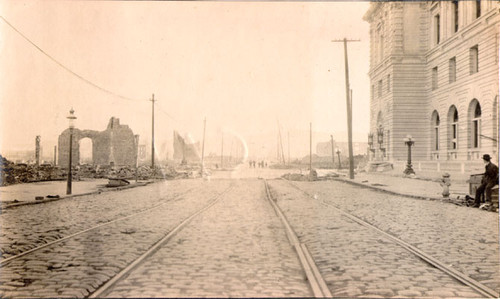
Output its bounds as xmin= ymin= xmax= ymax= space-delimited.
xmin=264 ymin=180 xmax=332 ymax=297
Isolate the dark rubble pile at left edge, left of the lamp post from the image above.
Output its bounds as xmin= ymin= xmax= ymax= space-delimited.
xmin=0 ymin=155 xmax=65 ymax=186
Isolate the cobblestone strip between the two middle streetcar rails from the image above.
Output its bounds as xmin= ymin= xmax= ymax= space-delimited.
xmin=103 ymin=180 xmax=311 ymax=298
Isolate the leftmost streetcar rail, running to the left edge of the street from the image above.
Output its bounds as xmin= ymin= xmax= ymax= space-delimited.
xmin=0 ymin=188 xmax=201 ymax=268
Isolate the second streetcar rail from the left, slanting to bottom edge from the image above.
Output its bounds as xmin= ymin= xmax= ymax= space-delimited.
xmin=88 ymin=184 xmax=234 ymax=298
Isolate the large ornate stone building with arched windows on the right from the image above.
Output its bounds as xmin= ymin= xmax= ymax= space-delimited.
xmin=364 ymin=0 xmax=500 ymax=173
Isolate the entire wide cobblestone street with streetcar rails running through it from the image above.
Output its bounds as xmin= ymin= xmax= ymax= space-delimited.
xmin=0 ymin=168 xmax=500 ymax=298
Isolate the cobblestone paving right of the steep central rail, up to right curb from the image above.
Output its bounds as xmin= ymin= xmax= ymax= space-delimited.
xmin=270 ymin=181 xmax=500 ymax=298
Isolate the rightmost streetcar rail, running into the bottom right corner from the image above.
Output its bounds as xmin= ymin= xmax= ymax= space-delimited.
xmin=280 ymin=181 xmax=500 ymax=298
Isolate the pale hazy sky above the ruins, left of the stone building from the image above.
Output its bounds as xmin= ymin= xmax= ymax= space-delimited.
xmin=0 ymin=1 xmax=369 ymax=158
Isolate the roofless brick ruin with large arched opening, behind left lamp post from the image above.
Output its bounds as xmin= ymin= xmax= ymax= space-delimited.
xmin=58 ymin=117 xmax=138 ymax=168
